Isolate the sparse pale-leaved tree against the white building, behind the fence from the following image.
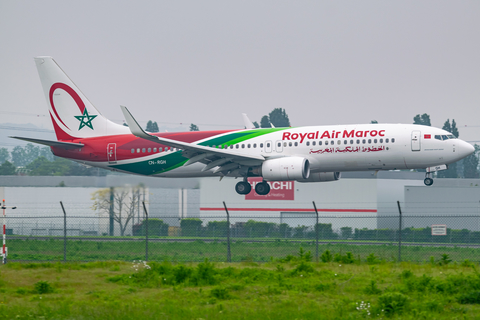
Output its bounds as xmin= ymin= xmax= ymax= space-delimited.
xmin=92 ymin=187 xmax=141 ymax=236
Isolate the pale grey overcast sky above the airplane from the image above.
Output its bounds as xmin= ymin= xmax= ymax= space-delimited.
xmin=0 ymin=0 xmax=480 ymax=140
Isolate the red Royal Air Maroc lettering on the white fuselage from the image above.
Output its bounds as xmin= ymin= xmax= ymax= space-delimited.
xmin=282 ymin=129 xmax=385 ymax=143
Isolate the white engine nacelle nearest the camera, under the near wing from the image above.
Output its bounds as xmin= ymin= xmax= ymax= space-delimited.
xmin=262 ymin=157 xmax=310 ymax=181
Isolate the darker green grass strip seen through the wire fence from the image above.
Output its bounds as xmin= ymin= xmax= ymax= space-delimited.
xmin=7 ymin=239 xmax=480 ymax=262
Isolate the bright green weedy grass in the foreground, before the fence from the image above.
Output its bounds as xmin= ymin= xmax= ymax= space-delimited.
xmin=0 ymin=250 xmax=480 ymax=320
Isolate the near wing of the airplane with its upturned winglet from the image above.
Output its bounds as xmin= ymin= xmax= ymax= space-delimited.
xmin=120 ymin=106 xmax=265 ymax=172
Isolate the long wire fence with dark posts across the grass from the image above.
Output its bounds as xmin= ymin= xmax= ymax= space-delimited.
xmin=5 ymin=203 xmax=480 ymax=262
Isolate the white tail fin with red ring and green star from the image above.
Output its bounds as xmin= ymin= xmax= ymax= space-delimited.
xmin=35 ymin=57 xmax=129 ymax=140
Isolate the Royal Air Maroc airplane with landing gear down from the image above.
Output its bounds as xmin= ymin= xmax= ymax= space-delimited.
xmin=12 ymin=56 xmax=474 ymax=195
